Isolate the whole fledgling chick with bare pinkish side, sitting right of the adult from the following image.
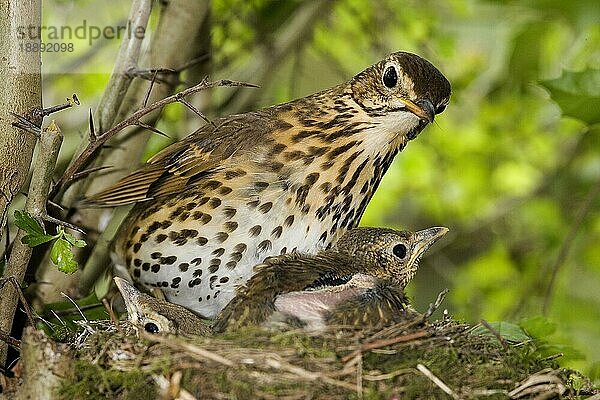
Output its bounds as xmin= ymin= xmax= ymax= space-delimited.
xmin=214 ymin=227 xmax=448 ymax=332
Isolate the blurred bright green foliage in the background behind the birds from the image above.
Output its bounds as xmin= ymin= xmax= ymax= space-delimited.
xmin=39 ymin=0 xmax=600 ymax=382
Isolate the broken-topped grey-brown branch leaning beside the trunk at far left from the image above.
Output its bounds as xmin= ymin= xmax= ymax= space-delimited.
xmin=0 ymin=122 xmax=62 ymax=364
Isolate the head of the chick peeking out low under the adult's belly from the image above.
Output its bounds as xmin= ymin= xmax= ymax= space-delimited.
xmin=114 ymin=277 xmax=209 ymax=335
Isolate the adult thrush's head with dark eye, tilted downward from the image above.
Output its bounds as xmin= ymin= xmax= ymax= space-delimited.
xmin=350 ymin=52 xmax=451 ymax=140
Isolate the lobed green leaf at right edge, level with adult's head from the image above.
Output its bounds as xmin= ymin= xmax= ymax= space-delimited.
xmin=540 ymin=69 xmax=600 ymax=125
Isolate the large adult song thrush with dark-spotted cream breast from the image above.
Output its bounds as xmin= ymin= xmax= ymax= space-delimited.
xmin=87 ymin=52 xmax=450 ymax=318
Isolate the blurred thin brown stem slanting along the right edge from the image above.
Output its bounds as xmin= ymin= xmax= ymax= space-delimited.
xmin=542 ymin=175 xmax=600 ymax=315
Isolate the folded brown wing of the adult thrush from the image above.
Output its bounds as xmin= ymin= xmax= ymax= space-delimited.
xmin=81 ymin=109 xmax=275 ymax=207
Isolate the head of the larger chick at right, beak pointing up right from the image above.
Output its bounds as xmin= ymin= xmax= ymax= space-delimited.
xmin=336 ymin=227 xmax=448 ymax=286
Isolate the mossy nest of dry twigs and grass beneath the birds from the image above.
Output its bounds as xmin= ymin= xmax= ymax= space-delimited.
xmin=4 ymin=312 xmax=593 ymax=399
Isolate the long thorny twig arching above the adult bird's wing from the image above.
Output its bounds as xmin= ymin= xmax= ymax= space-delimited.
xmin=51 ymin=79 xmax=256 ymax=197
